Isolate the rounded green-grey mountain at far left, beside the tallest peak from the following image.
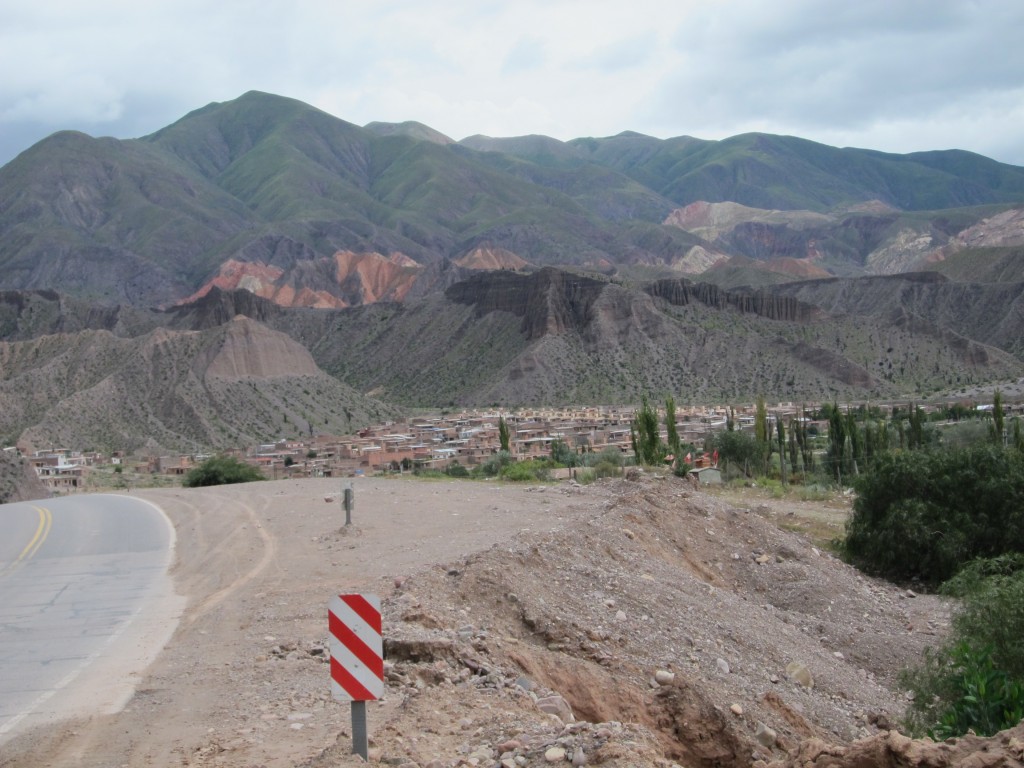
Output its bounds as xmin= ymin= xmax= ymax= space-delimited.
xmin=0 ymin=132 xmax=251 ymax=305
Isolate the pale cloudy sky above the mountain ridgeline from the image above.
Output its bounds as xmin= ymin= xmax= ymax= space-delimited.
xmin=0 ymin=0 xmax=1024 ymax=165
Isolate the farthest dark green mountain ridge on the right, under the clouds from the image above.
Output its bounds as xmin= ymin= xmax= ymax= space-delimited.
xmin=570 ymin=133 xmax=1024 ymax=211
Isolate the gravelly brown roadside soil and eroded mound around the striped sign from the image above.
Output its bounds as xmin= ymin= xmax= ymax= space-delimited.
xmin=0 ymin=477 xmax=948 ymax=768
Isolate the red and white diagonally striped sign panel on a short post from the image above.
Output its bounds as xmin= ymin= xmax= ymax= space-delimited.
xmin=328 ymin=595 xmax=384 ymax=701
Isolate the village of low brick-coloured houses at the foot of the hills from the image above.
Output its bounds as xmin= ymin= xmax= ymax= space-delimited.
xmin=18 ymin=402 xmax=1020 ymax=494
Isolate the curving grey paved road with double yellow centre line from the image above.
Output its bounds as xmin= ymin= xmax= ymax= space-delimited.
xmin=0 ymin=495 xmax=175 ymax=743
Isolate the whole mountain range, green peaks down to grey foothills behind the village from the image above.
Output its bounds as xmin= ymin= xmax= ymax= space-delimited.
xmin=0 ymin=92 xmax=1024 ymax=460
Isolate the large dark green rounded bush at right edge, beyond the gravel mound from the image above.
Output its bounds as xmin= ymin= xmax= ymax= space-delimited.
xmin=842 ymin=445 xmax=1024 ymax=586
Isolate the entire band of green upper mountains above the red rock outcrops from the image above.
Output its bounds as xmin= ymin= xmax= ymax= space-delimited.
xmin=0 ymin=91 xmax=1024 ymax=306
